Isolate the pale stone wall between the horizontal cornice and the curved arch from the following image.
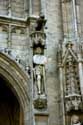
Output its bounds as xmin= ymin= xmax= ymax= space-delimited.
xmin=0 ymin=22 xmax=29 ymax=67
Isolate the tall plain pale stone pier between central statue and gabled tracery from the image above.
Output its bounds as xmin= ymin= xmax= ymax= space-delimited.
xmin=45 ymin=0 xmax=63 ymax=125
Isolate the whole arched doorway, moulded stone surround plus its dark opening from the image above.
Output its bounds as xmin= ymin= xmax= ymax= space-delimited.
xmin=0 ymin=52 xmax=30 ymax=125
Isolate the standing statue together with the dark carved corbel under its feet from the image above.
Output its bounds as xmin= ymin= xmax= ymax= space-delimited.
xmin=34 ymin=59 xmax=47 ymax=109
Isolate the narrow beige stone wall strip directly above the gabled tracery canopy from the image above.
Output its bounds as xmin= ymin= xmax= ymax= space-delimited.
xmin=62 ymin=1 xmax=75 ymax=42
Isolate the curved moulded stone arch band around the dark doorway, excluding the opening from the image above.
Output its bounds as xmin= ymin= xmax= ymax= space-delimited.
xmin=0 ymin=52 xmax=30 ymax=125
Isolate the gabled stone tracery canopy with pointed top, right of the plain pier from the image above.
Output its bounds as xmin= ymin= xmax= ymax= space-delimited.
xmin=58 ymin=41 xmax=83 ymax=124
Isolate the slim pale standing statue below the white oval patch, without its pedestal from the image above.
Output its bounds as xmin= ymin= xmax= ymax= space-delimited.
xmin=34 ymin=65 xmax=45 ymax=95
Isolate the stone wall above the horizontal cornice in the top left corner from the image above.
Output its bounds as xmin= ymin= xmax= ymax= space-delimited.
xmin=0 ymin=0 xmax=29 ymax=18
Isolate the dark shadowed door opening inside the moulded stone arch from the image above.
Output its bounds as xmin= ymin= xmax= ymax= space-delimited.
xmin=0 ymin=76 xmax=24 ymax=125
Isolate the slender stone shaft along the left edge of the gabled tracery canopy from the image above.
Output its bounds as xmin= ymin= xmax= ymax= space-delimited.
xmin=59 ymin=64 xmax=65 ymax=125
